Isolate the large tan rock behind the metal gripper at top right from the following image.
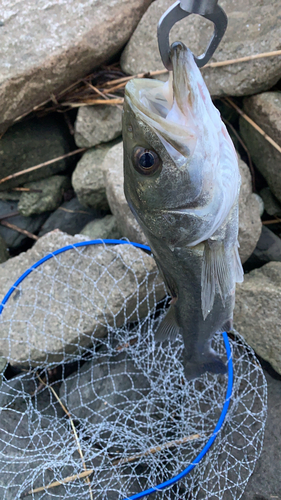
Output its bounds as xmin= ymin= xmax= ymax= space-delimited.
xmin=121 ymin=0 xmax=281 ymax=96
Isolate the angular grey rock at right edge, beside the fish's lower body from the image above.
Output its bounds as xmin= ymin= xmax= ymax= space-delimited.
xmin=234 ymin=262 xmax=281 ymax=373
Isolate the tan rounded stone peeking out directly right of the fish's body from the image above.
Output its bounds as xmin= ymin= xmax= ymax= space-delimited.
xmin=238 ymin=158 xmax=262 ymax=263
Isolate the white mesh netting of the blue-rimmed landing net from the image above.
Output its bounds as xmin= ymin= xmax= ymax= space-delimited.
xmin=0 ymin=240 xmax=266 ymax=500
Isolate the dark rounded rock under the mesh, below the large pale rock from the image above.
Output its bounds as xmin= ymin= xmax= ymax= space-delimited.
xmin=60 ymin=353 xmax=151 ymax=427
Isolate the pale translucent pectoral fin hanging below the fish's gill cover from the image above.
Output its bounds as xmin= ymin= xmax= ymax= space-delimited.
xmin=201 ymin=240 xmax=243 ymax=319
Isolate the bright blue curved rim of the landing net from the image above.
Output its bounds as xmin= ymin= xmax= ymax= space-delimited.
xmin=0 ymin=239 xmax=233 ymax=500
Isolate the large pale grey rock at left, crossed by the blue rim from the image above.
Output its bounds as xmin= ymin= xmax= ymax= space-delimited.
xmin=0 ymin=231 xmax=165 ymax=366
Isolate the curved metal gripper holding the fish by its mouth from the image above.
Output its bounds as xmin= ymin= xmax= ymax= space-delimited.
xmin=157 ymin=0 xmax=227 ymax=71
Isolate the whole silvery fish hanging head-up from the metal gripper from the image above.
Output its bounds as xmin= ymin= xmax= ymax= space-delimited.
xmin=122 ymin=42 xmax=243 ymax=380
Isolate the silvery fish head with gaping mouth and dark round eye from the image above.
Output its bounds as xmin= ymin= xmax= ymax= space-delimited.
xmin=123 ymin=43 xmax=237 ymax=244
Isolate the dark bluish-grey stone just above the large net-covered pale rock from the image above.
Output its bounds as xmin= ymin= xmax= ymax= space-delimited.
xmin=39 ymin=198 xmax=101 ymax=236
